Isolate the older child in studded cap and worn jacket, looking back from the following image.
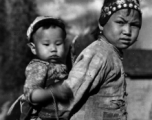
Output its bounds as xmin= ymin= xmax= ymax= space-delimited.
xmin=59 ymin=0 xmax=142 ymax=120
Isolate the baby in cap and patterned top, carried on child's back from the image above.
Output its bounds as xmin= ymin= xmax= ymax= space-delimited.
xmin=21 ymin=16 xmax=72 ymax=120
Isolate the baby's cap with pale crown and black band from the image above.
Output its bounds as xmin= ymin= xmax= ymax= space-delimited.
xmin=27 ymin=16 xmax=66 ymax=42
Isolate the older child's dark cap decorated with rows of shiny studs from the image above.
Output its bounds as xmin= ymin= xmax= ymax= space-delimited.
xmin=99 ymin=0 xmax=141 ymax=27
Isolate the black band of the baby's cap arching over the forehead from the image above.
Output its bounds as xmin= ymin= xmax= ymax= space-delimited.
xmin=29 ymin=19 xmax=66 ymax=42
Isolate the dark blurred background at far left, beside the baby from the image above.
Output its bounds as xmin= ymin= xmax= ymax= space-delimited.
xmin=0 ymin=0 xmax=37 ymax=105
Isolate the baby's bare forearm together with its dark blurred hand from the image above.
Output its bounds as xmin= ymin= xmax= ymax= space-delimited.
xmin=31 ymin=83 xmax=73 ymax=104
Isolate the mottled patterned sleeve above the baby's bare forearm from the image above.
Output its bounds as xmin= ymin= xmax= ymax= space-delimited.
xmin=24 ymin=62 xmax=47 ymax=102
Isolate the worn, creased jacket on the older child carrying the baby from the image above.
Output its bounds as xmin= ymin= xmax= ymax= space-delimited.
xmin=59 ymin=36 xmax=127 ymax=120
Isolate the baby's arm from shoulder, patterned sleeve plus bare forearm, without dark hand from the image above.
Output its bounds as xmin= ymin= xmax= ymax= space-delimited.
xmin=24 ymin=62 xmax=56 ymax=105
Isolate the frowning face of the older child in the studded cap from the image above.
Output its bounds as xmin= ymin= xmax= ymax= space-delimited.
xmin=103 ymin=9 xmax=141 ymax=49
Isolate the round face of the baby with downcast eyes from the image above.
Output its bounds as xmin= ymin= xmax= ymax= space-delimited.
xmin=33 ymin=27 xmax=65 ymax=63
